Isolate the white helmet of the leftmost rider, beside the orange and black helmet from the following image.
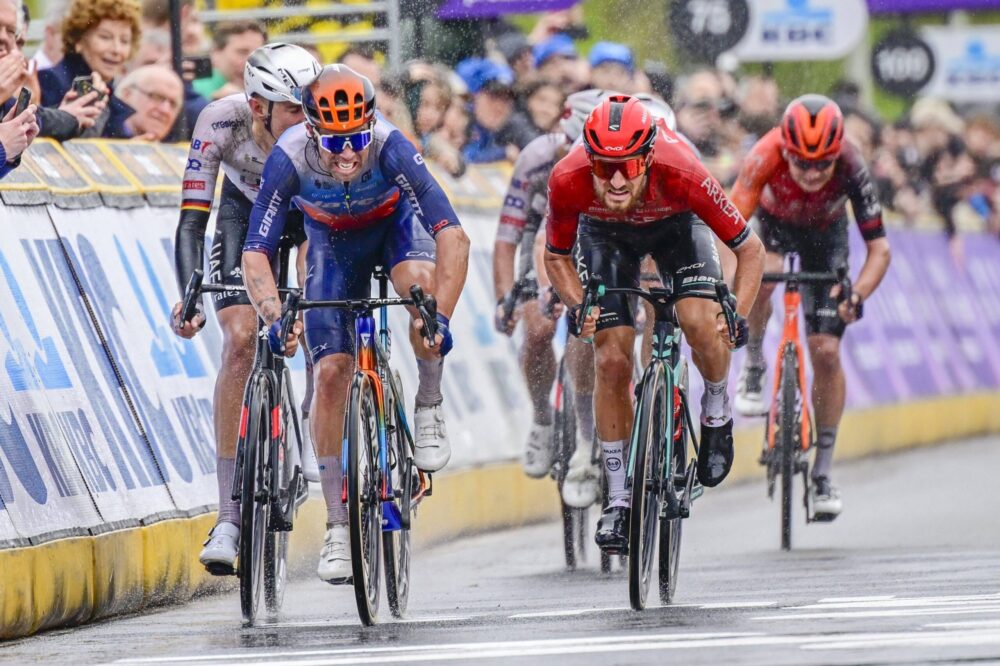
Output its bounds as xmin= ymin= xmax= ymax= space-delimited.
xmin=243 ymin=42 xmax=320 ymax=104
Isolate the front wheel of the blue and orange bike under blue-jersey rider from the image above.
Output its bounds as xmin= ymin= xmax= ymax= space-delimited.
xmin=345 ymin=374 xmax=382 ymax=626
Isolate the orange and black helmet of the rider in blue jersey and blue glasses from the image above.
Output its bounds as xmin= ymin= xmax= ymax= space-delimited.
xmin=302 ymin=65 xmax=375 ymax=134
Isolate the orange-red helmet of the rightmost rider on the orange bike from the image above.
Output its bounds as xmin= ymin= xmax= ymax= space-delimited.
xmin=781 ymin=95 xmax=844 ymax=160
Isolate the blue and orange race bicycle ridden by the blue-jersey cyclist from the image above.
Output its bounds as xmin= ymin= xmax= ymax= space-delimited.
xmin=279 ymin=266 xmax=437 ymax=626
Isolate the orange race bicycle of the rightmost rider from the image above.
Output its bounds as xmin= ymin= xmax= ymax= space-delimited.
xmin=760 ymin=254 xmax=851 ymax=550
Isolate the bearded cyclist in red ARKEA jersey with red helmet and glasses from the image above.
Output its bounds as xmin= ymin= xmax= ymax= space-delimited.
xmin=545 ymin=95 xmax=764 ymax=550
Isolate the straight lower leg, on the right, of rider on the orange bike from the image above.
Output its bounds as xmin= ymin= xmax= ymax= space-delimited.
xmin=808 ymin=333 xmax=847 ymax=478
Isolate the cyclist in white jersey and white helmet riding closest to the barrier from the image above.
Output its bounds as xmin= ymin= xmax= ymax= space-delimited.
xmin=173 ymin=43 xmax=319 ymax=575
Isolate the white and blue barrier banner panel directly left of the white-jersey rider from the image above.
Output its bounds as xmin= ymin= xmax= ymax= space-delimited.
xmin=53 ymin=209 xmax=217 ymax=511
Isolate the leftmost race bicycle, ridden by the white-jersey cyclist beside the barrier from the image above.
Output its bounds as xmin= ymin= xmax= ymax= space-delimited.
xmin=181 ymin=255 xmax=308 ymax=626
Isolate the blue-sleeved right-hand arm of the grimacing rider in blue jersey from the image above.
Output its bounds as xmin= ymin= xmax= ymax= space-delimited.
xmin=380 ymin=131 xmax=469 ymax=317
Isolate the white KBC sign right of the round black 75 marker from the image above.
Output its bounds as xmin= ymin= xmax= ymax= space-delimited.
xmin=732 ymin=0 xmax=868 ymax=62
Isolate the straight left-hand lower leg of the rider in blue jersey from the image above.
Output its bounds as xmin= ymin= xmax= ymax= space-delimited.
xmin=309 ymin=354 xmax=354 ymax=526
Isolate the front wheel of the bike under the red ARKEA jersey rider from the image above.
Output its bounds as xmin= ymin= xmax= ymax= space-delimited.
xmin=628 ymin=363 xmax=673 ymax=610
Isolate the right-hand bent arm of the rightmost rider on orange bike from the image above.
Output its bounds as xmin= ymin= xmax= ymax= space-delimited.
xmin=842 ymin=146 xmax=890 ymax=301
